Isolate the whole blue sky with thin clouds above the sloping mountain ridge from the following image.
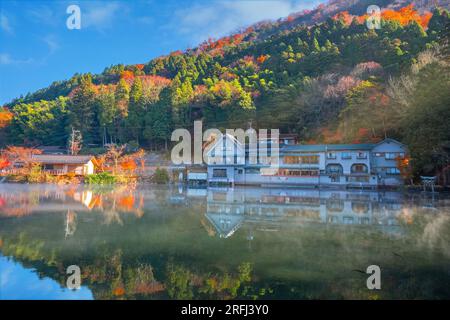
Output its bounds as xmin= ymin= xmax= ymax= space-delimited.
xmin=0 ymin=0 xmax=325 ymax=105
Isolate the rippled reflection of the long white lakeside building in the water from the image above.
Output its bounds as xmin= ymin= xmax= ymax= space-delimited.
xmin=200 ymin=189 xmax=403 ymax=240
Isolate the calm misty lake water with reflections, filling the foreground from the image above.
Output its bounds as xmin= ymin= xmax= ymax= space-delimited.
xmin=0 ymin=184 xmax=450 ymax=299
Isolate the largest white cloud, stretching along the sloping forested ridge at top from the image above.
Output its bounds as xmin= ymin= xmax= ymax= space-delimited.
xmin=171 ymin=0 xmax=323 ymax=43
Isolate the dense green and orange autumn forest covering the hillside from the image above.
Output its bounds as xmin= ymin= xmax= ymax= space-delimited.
xmin=0 ymin=1 xmax=450 ymax=178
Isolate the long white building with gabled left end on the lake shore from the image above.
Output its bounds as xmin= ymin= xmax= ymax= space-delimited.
xmin=207 ymin=135 xmax=407 ymax=188
